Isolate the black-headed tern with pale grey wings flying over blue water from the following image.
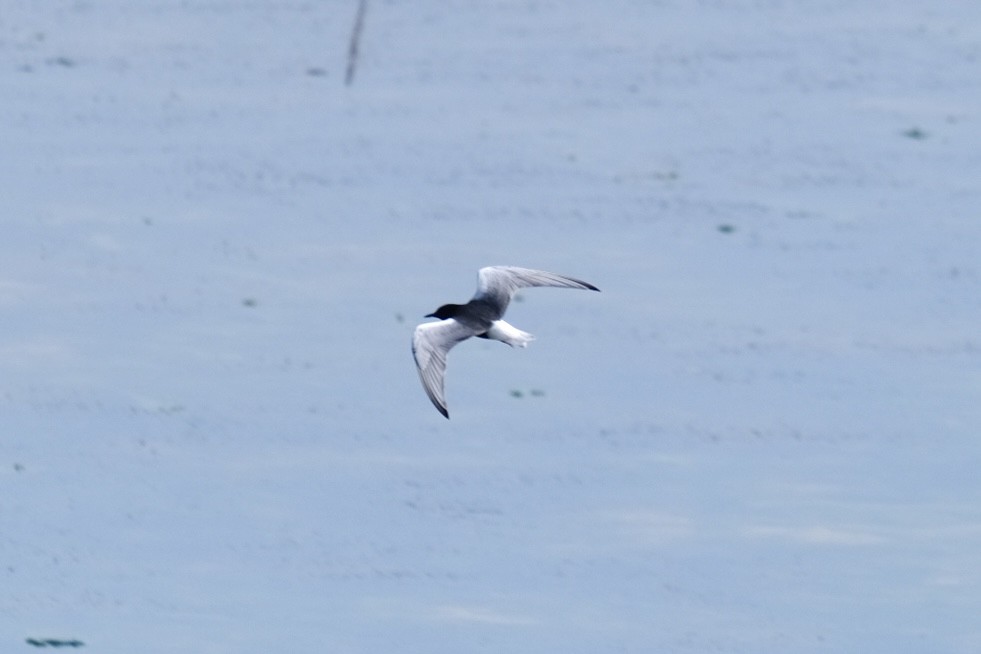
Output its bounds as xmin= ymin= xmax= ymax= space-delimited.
xmin=412 ymin=266 xmax=599 ymax=418
